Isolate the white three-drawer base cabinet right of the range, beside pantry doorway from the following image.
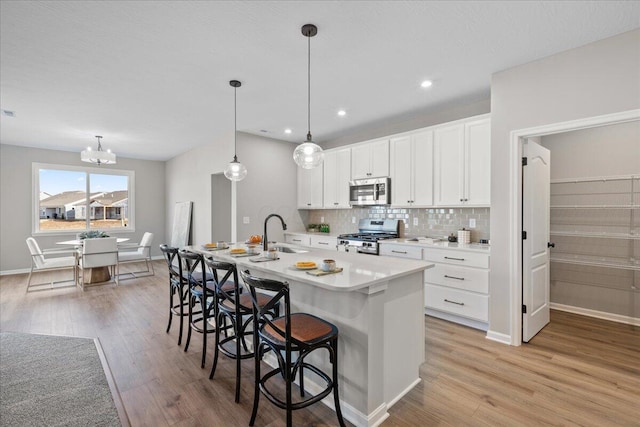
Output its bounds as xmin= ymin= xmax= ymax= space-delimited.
xmin=423 ymin=248 xmax=489 ymax=330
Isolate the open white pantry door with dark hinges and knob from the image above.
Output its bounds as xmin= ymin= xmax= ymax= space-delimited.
xmin=522 ymin=141 xmax=551 ymax=342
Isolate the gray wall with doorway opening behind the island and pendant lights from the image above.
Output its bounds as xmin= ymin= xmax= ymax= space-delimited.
xmin=166 ymin=132 xmax=303 ymax=249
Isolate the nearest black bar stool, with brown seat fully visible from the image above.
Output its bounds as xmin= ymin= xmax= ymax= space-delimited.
xmin=240 ymin=270 xmax=345 ymax=427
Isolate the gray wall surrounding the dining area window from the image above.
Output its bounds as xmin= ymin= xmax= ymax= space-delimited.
xmin=0 ymin=144 xmax=165 ymax=273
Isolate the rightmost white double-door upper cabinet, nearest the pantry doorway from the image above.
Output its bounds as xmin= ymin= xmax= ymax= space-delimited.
xmin=434 ymin=118 xmax=491 ymax=206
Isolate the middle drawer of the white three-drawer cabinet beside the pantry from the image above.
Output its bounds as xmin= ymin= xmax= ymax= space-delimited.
xmin=424 ymin=264 xmax=489 ymax=294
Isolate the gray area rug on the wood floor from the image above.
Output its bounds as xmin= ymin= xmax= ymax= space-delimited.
xmin=0 ymin=332 xmax=121 ymax=426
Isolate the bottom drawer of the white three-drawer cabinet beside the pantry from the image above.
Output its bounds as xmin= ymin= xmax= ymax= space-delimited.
xmin=424 ymin=284 xmax=489 ymax=322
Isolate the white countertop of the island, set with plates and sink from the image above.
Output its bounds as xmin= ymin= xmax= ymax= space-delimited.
xmin=187 ymin=243 xmax=434 ymax=291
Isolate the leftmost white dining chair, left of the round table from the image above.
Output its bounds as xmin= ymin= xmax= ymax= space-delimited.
xmin=27 ymin=237 xmax=78 ymax=292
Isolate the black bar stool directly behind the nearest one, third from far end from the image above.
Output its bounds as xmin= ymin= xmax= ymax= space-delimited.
xmin=204 ymin=258 xmax=280 ymax=403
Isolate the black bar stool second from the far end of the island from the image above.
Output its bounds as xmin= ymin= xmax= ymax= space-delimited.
xmin=180 ymin=250 xmax=235 ymax=368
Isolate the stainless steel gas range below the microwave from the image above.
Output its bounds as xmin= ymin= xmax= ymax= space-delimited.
xmin=338 ymin=218 xmax=402 ymax=255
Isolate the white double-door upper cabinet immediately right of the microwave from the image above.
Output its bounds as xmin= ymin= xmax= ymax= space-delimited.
xmin=390 ymin=131 xmax=433 ymax=207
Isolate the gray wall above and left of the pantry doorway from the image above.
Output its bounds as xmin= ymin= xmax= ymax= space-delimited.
xmin=489 ymin=30 xmax=640 ymax=337
